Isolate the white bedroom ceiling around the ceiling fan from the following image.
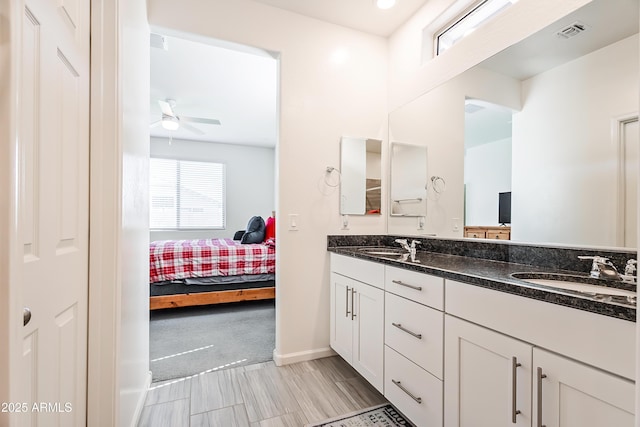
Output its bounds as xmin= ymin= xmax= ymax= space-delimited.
xmin=149 ymin=36 xmax=277 ymax=147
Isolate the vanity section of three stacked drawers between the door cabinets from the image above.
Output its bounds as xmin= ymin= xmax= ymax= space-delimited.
xmin=384 ymin=266 xmax=444 ymax=427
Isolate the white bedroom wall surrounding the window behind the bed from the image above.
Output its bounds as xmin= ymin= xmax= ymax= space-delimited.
xmin=150 ymin=138 xmax=276 ymax=241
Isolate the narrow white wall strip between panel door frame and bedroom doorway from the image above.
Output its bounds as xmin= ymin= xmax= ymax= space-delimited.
xmin=118 ymin=0 xmax=151 ymax=426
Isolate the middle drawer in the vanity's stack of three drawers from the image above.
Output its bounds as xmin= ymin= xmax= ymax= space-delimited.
xmin=384 ymin=293 xmax=444 ymax=379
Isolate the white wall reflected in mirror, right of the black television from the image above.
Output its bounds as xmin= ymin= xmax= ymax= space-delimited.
xmin=511 ymin=35 xmax=639 ymax=246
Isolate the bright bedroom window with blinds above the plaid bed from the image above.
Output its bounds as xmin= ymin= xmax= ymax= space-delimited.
xmin=149 ymin=158 xmax=225 ymax=230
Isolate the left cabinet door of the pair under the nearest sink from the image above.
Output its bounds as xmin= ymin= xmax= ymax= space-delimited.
xmin=444 ymin=315 xmax=532 ymax=427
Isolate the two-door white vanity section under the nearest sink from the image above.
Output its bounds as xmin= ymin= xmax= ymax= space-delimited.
xmin=444 ymin=281 xmax=635 ymax=427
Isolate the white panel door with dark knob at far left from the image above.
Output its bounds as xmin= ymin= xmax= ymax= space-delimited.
xmin=10 ymin=0 xmax=89 ymax=426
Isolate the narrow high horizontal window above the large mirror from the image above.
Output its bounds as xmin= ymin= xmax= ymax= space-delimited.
xmin=435 ymin=0 xmax=517 ymax=55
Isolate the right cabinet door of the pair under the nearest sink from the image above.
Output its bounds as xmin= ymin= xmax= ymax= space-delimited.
xmin=533 ymin=348 xmax=635 ymax=427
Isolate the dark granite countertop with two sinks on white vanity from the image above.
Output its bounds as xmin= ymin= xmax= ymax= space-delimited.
xmin=327 ymin=246 xmax=636 ymax=322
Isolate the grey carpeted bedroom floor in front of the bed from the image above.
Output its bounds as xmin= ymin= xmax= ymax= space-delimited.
xmin=149 ymin=300 xmax=275 ymax=382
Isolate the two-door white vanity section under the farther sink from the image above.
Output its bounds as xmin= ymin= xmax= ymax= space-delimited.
xmin=330 ymin=254 xmax=384 ymax=393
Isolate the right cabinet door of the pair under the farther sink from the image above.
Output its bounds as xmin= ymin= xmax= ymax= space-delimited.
xmin=351 ymin=282 xmax=384 ymax=393
